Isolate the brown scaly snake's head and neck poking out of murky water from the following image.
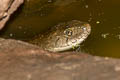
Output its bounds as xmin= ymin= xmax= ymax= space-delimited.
xmin=31 ymin=20 xmax=91 ymax=52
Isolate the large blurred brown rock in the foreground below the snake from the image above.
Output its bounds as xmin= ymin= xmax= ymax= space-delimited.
xmin=0 ymin=38 xmax=120 ymax=80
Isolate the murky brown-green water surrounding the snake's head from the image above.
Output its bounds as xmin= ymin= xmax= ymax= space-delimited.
xmin=1 ymin=0 xmax=120 ymax=58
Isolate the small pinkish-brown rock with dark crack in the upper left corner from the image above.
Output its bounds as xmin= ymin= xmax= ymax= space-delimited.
xmin=0 ymin=0 xmax=24 ymax=29
